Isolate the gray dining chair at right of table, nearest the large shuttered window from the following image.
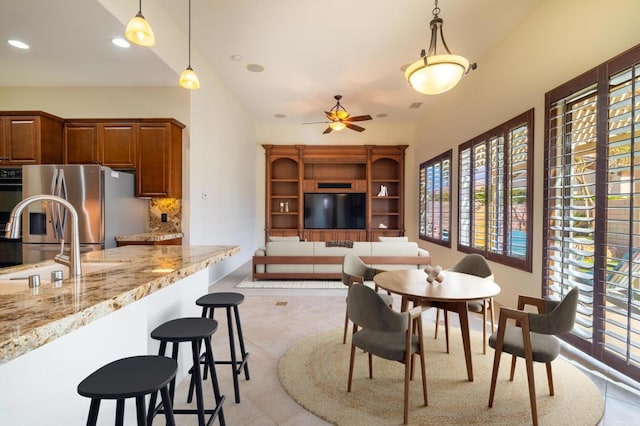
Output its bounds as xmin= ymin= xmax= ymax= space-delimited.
xmin=489 ymin=287 xmax=579 ymax=425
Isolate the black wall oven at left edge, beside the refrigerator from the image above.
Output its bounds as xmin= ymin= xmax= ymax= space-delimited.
xmin=0 ymin=167 xmax=22 ymax=268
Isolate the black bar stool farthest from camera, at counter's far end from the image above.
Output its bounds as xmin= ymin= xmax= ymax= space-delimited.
xmin=196 ymin=292 xmax=249 ymax=403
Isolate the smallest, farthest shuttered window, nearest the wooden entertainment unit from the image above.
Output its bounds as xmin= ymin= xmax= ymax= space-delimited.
xmin=418 ymin=150 xmax=452 ymax=247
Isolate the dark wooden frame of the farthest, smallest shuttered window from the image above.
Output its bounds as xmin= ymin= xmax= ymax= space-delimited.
xmin=418 ymin=149 xmax=453 ymax=248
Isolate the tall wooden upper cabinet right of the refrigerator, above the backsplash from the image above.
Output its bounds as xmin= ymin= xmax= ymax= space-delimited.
xmin=136 ymin=120 xmax=184 ymax=198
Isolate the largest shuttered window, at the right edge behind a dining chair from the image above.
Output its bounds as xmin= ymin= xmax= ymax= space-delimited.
xmin=543 ymin=46 xmax=640 ymax=380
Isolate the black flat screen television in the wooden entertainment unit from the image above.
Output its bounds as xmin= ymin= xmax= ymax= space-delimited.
xmin=304 ymin=192 xmax=367 ymax=229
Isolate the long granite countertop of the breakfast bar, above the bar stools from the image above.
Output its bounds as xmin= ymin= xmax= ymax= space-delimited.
xmin=0 ymin=246 xmax=240 ymax=364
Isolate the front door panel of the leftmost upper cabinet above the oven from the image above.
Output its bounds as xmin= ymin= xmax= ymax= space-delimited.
xmin=4 ymin=116 xmax=40 ymax=164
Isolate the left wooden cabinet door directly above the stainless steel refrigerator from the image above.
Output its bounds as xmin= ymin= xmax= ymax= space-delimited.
xmin=64 ymin=123 xmax=98 ymax=164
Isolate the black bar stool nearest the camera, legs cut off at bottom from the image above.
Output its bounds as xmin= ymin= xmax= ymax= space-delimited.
xmin=78 ymin=355 xmax=178 ymax=426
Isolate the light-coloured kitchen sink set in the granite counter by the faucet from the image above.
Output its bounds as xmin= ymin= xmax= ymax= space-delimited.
xmin=0 ymin=262 xmax=126 ymax=294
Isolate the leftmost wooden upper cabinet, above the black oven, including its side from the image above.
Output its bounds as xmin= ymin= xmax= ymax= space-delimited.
xmin=0 ymin=111 xmax=63 ymax=165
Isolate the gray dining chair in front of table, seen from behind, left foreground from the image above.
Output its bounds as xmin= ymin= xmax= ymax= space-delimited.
xmin=347 ymin=284 xmax=428 ymax=424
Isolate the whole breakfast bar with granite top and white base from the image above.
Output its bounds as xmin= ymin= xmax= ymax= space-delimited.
xmin=0 ymin=246 xmax=239 ymax=425
